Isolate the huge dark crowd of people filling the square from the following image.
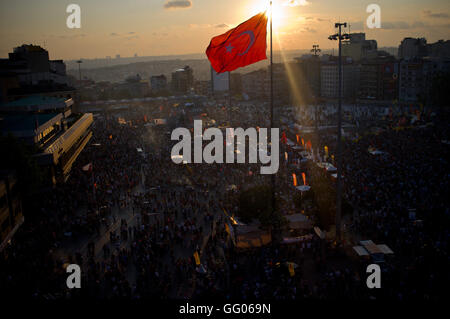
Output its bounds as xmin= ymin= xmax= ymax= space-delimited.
xmin=0 ymin=101 xmax=449 ymax=300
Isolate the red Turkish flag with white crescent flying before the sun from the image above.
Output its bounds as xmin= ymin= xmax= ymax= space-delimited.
xmin=206 ymin=12 xmax=267 ymax=73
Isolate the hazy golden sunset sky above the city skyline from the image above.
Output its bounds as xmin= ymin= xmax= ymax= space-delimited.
xmin=0 ymin=0 xmax=450 ymax=60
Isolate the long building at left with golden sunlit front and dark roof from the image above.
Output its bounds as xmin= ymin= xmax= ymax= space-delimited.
xmin=0 ymin=96 xmax=93 ymax=183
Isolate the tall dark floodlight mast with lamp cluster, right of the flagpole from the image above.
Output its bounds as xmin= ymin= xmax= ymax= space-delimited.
xmin=328 ymin=22 xmax=349 ymax=244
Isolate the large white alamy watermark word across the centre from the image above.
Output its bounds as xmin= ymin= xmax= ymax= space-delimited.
xmin=171 ymin=120 xmax=279 ymax=174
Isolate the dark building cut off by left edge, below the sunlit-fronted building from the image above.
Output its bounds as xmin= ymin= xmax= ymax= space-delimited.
xmin=0 ymin=172 xmax=24 ymax=252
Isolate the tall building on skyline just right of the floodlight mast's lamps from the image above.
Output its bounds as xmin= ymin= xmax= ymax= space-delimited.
xmin=342 ymin=33 xmax=377 ymax=62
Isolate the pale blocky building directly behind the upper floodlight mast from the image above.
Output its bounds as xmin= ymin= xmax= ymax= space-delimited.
xmin=320 ymin=58 xmax=360 ymax=99
